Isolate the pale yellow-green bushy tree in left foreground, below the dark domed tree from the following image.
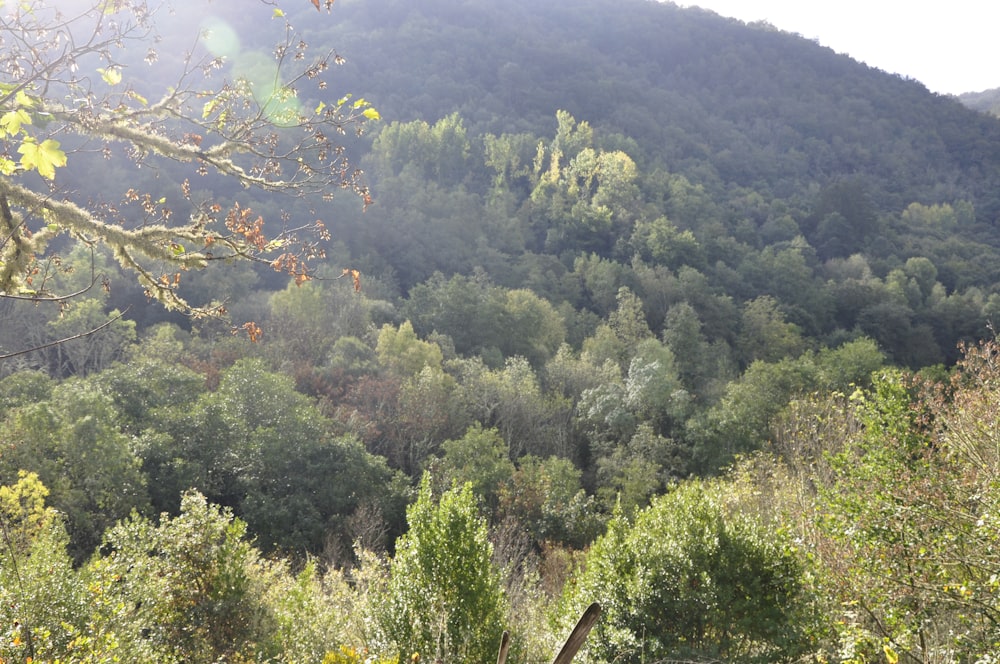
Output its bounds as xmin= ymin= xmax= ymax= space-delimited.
xmin=83 ymin=492 xmax=278 ymax=663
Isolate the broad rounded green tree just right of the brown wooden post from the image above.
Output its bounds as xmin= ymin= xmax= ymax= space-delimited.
xmin=563 ymin=481 xmax=807 ymax=662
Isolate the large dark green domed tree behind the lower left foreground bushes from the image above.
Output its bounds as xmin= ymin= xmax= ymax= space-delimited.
xmin=143 ymin=359 xmax=401 ymax=554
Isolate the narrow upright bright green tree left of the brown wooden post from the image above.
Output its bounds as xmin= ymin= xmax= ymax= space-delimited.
xmin=381 ymin=476 xmax=506 ymax=662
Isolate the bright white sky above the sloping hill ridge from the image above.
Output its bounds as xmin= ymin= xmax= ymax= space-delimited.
xmin=676 ymin=0 xmax=1000 ymax=95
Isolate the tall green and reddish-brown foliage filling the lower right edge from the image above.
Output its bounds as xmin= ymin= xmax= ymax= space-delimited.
xmin=796 ymin=343 xmax=998 ymax=661
